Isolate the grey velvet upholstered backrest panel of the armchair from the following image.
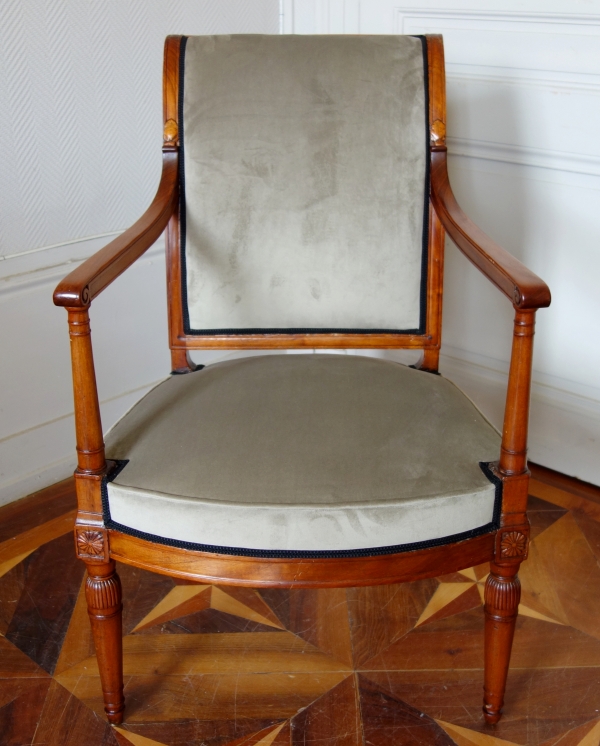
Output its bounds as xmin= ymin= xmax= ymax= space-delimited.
xmin=181 ymin=35 xmax=427 ymax=333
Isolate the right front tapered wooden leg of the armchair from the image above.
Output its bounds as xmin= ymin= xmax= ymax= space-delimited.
xmin=483 ymin=562 xmax=521 ymax=723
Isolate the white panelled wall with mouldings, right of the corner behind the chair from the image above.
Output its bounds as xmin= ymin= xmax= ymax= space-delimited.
xmin=283 ymin=0 xmax=600 ymax=484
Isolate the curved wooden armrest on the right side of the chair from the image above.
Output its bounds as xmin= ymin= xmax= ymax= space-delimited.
xmin=431 ymin=150 xmax=550 ymax=309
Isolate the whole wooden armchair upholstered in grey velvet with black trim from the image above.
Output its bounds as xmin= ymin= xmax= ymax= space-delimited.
xmin=54 ymin=36 xmax=550 ymax=723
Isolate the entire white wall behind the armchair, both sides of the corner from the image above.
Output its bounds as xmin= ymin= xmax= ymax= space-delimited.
xmin=0 ymin=0 xmax=600 ymax=504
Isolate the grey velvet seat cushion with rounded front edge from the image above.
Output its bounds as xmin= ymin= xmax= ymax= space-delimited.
xmin=105 ymin=354 xmax=500 ymax=556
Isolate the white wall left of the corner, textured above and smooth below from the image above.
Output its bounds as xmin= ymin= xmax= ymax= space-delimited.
xmin=0 ymin=0 xmax=279 ymax=504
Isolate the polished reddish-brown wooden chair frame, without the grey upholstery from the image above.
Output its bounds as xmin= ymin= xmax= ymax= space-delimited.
xmin=54 ymin=35 xmax=550 ymax=723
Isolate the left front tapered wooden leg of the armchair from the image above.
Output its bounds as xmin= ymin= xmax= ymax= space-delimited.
xmin=85 ymin=562 xmax=125 ymax=724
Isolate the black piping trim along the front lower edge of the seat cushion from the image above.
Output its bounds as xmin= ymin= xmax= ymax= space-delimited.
xmin=102 ymin=461 xmax=502 ymax=559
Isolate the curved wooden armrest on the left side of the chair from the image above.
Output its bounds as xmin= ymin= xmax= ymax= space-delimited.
xmin=54 ymin=152 xmax=178 ymax=308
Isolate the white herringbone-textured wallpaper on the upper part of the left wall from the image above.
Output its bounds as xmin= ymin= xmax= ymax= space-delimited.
xmin=0 ymin=0 xmax=279 ymax=256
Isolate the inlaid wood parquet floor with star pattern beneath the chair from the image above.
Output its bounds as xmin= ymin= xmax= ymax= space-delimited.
xmin=0 ymin=470 xmax=600 ymax=746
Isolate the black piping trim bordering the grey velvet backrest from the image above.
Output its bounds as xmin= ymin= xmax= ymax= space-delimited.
xmin=178 ymin=36 xmax=431 ymax=337
